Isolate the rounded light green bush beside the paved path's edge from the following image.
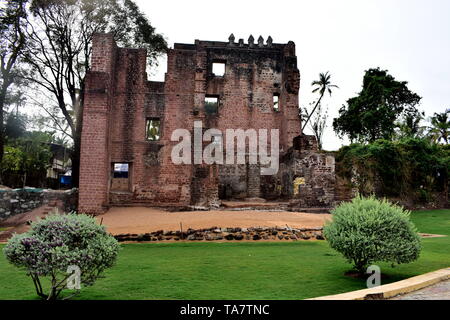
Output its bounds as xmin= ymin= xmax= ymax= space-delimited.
xmin=324 ymin=196 xmax=421 ymax=273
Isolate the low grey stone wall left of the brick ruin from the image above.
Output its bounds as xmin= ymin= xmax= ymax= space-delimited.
xmin=0 ymin=189 xmax=78 ymax=220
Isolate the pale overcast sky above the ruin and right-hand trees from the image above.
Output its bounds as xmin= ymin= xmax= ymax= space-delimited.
xmin=136 ymin=0 xmax=450 ymax=150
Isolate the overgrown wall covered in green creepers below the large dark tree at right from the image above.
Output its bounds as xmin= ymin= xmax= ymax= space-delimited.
xmin=336 ymin=138 xmax=450 ymax=203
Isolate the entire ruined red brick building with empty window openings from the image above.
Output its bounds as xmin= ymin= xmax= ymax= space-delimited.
xmin=79 ymin=34 xmax=335 ymax=213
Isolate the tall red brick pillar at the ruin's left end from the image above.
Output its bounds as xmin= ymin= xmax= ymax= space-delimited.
xmin=78 ymin=34 xmax=117 ymax=213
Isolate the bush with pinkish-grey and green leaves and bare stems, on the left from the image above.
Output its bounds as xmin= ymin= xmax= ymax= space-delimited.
xmin=3 ymin=214 xmax=119 ymax=300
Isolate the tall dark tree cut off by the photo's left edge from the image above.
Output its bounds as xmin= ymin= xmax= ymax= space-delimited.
xmin=0 ymin=0 xmax=27 ymax=170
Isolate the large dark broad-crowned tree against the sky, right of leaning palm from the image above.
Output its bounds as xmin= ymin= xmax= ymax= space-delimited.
xmin=333 ymin=68 xmax=421 ymax=142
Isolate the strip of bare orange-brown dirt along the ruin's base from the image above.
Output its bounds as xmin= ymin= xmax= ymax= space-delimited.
xmin=98 ymin=207 xmax=331 ymax=235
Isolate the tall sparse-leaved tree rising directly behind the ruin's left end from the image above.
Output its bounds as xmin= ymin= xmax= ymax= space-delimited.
xmin=25 ymin=0 xmax=167 ymax=185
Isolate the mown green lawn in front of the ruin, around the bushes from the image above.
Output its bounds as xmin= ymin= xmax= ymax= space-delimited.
xmin=0 ymin=210 xmax=450 ymax=299
